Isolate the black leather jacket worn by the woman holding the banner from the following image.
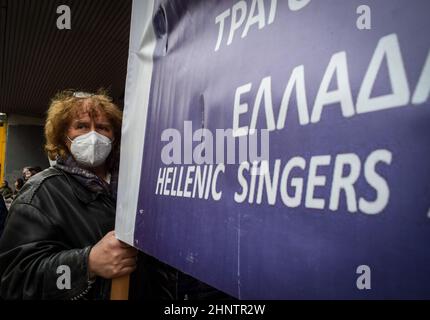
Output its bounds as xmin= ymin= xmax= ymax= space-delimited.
xmin=0 ymin=167 xmax=115 ymax=299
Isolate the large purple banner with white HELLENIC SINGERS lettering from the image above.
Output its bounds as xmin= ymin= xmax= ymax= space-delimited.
xmin=116 ymin=0 xmax=430 ymax=299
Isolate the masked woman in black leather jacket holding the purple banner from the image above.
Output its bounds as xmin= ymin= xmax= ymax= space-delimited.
xmin=0 ymin=92 xmax=137 ymax=299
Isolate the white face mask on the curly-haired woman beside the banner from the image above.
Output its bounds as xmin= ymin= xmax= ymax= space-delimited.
xmin=67 ymin=131 xmax=112 ymax=167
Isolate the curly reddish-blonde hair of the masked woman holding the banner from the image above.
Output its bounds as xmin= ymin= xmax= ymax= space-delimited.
xmin=45 ymin=89 xmax=122 ymax=165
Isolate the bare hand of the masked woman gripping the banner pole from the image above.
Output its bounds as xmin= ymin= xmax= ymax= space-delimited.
xmin=88 ymin=231 xmax=137 ymax=279
